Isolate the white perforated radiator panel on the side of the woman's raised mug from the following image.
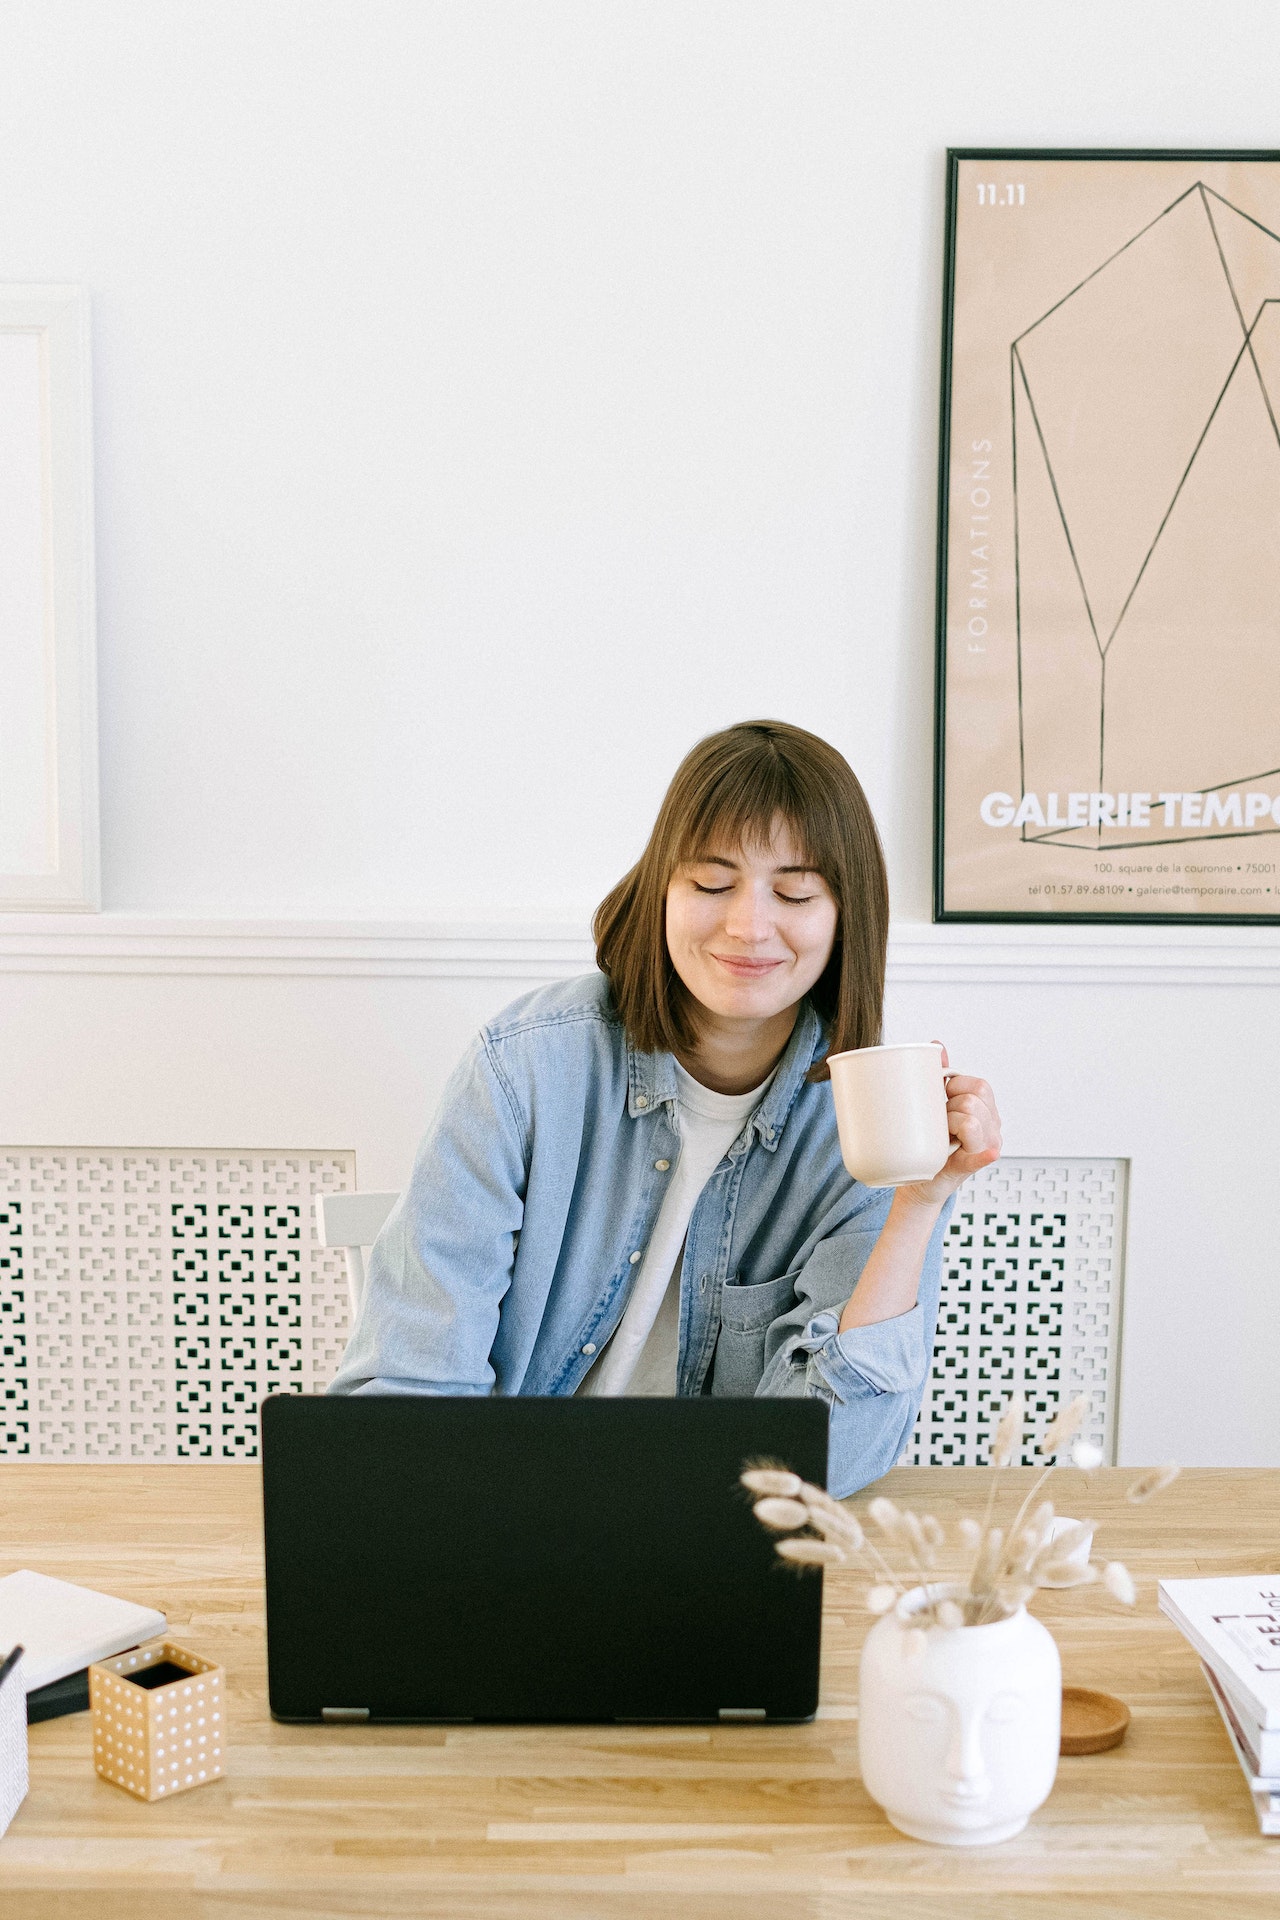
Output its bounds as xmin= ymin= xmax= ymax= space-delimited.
xmin=904 ymin=1160 xmax=1126 ymax=1467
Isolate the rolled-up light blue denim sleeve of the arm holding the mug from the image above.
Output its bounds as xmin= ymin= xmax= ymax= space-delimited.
xmin=756 ymin=1194 xmax=956 ymax=1498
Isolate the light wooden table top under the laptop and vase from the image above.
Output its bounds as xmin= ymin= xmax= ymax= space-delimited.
xmin=0 ymin=1463 xmax=1280 ymax=1920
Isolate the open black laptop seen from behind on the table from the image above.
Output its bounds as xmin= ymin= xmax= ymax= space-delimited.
xmin=261 ymin=1394 xmax=827 ymax=1722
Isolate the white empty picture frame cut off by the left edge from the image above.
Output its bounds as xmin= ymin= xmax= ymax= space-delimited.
xmin=0 ymin=284 xmax=100 ymax=912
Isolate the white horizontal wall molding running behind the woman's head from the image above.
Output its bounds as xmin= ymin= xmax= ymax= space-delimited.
xmin=0 ymin=914 xmax=1280 ymax=987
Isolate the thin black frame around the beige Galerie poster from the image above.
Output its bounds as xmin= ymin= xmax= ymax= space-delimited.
xmin=933 ymin=146 xmax=1280 ymax=927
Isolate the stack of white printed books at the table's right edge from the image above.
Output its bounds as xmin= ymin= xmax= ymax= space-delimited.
xmin=1159 ymin=1574 xmax=1280 ymax=1834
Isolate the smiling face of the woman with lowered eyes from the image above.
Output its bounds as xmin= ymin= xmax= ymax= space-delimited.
xmin=666 ymin=820 xmax=837 ymax=1020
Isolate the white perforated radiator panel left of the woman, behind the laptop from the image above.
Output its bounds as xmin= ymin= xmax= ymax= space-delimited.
xmin=0 ymin=1146 xmax=355 ymax=1461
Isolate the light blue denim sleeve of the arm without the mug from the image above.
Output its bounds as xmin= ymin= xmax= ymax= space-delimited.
xmin=328 ymin=1035 xmax=528 ymax=1394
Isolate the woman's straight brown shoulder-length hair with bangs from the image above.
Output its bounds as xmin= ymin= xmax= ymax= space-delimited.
xmin=591 ymin=720 xmax=889 ymax=1079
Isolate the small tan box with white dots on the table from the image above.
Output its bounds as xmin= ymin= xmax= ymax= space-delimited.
xmin=88 ymin=1640 xmax=226 ymax=1801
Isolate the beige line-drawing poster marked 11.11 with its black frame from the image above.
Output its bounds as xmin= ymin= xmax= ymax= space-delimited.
xmin=935 ymin=150 xmax=1280 ymax=924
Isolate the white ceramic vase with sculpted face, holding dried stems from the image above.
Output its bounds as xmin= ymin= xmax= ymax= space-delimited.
xmin=858 ymin=1611 xmax=1061 ymax=1847
